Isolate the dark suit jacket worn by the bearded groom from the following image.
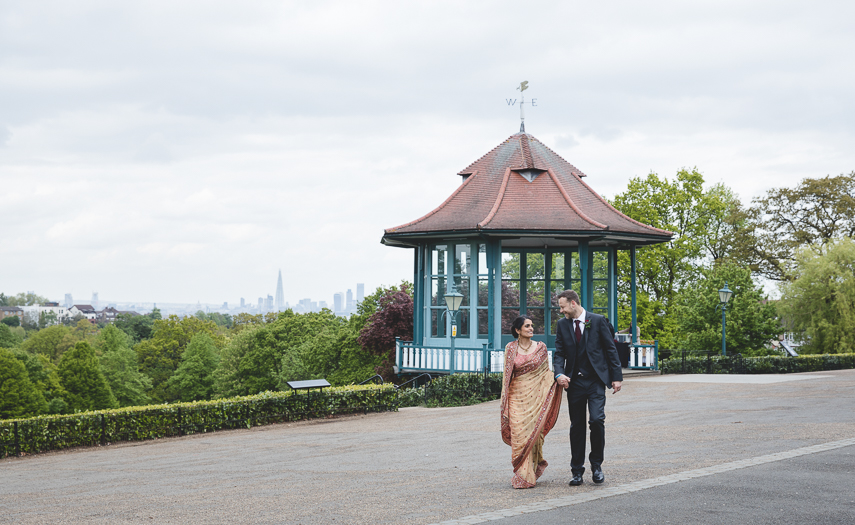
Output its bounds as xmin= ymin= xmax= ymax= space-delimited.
xmin=552 ymin=310 xmax=623 ymax=387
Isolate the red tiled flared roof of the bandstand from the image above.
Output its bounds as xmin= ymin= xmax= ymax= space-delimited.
xmin=386 ymin=133 xmax=671 ymax=238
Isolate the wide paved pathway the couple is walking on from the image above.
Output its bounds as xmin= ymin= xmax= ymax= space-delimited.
xmin=5 ymin=370 xmax=855 ymax=524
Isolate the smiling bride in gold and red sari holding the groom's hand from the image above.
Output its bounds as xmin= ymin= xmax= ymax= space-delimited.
xmin=502 ymin=316 xmax=562 ymax=489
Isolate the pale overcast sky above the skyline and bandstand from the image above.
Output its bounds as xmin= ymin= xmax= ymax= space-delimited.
xmin=0 ymin=0 xmax=855 ymax=304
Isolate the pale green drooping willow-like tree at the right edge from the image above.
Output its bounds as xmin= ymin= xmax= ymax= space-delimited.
xmin=780 ymin=238 xmax=855 ymax=354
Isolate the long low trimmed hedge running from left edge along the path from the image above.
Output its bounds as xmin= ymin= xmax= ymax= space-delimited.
xmin=0 ymin=385 xmax=398 ymax=458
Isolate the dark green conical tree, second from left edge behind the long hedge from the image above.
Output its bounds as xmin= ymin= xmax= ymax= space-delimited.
xmin=58 ymin=341 xmax=117 ymax=412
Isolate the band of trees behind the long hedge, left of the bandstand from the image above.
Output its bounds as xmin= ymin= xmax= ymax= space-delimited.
xmin=0 ymin=283 xmax=413 ymax=419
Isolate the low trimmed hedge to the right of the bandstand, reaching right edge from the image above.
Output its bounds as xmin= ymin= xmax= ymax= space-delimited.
xmin=659 ymin=354 xmax=855 ymax=374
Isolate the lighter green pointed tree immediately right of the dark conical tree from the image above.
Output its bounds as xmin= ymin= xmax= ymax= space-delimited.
xmin=97 ymin=325 xmax=152 ymax=407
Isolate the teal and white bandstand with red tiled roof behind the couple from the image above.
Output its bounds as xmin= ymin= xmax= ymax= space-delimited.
xmin=382 ymin=132 xmax=671 ymax=375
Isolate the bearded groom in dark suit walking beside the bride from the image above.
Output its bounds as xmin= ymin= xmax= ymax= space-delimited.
xmin=552 ymin=290 xmax=623 ymax=486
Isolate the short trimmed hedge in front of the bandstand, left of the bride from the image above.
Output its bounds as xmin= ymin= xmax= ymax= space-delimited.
xmin=398 ymin=373 xmax=502 ymax=407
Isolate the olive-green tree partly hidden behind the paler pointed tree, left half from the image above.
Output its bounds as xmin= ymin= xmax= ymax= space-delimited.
xmin=134 ymin=315 xmax=225 ymax=402
